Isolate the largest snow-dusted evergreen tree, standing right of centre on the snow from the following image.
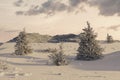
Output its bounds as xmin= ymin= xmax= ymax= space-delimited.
xmin=77 ymin=22 xmax=103 ymax=60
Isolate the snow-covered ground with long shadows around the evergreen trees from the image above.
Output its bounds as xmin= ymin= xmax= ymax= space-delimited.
xmin=0 ymin=42 xmax=120 ymax=80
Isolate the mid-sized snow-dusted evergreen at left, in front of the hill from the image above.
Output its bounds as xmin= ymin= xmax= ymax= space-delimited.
xmin=15 ymin=29 xmax=32 ymax=55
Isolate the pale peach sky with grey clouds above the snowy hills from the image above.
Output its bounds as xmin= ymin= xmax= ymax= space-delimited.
xmin=0 ymin=0 xmax=120 ymax=42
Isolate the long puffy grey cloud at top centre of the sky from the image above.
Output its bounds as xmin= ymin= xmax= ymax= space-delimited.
xmin=25 ymin=0 xmax=68 ymax=15
